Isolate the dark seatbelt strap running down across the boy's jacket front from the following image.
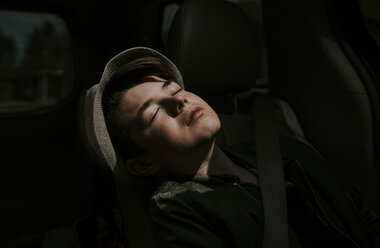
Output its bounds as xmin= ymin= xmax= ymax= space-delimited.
xmin=252 ymin=94 xmax=289 ymax=248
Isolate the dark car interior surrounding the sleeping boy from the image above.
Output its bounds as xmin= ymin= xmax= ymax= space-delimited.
xmin=0 ymin=0 xmax=380 ymax=248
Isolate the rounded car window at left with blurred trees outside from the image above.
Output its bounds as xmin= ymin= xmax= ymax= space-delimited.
xmin=0 ymin=10 xmax=73 ymax=113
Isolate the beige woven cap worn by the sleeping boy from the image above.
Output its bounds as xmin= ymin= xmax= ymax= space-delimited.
xmin=85 ymin=47 xmax=184 ymax=173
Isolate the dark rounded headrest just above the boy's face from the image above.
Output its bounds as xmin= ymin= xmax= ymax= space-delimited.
xmin=165 ymin=0 xmax=259 ymax=95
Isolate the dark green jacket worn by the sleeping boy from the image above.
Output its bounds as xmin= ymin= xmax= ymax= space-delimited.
xmin=150 ymin=138 xmax=380 ymax=248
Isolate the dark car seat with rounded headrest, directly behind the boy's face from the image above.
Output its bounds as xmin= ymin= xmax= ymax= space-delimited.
xmin=166 ymin=0 xmax=304 ymax=146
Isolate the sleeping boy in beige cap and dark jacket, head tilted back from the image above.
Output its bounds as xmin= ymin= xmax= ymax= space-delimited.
xmin=87 ymin=47 xmax=380 ymax=247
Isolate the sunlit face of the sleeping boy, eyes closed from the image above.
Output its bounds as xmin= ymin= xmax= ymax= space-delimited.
xmin=117 ymin=76 xmax=220 ymax=175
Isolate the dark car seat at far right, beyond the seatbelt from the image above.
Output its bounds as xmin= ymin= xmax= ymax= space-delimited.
xmin=262 ymin=0 xmax=380 ymax=214
